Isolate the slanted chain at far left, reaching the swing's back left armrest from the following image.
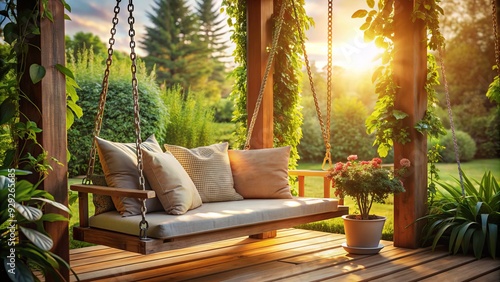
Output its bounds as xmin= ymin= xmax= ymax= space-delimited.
xmin=82 ymin=0 xmax=121 ymax=184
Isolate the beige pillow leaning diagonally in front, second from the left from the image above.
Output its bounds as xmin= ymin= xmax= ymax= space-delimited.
xmin=142 ymin=150 xmax=202 ymax=215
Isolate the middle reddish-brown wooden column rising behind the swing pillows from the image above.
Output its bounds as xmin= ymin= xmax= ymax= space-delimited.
xmin=247 ymin=0 xmax=274 ymax=149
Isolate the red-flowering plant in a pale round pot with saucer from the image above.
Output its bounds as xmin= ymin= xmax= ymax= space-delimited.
xmin=328 ymin=155 xmax=411 ymax=254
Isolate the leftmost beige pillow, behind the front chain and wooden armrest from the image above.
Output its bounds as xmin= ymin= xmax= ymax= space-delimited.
xmin=96 ymin=136 xmax=163 ymax=216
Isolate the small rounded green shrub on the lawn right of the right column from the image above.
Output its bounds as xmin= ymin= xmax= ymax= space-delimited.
xmin=432 ymin=130 xmax=476 ymax=163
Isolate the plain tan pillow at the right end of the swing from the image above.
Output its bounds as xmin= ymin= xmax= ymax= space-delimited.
xmin=228 ymin=146 xmax=292 ymax=199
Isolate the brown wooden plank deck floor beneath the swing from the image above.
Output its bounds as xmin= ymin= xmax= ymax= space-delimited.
xmin=70 ymin=229 xmax=500 ymax=282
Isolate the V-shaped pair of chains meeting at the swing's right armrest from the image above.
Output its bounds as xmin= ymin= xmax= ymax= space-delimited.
xmin=293 ymin=0 xmax=333 ymax=170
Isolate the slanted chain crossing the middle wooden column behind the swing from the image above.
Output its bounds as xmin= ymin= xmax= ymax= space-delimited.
xmin=245 ymin=1 xmax=293 ymax=150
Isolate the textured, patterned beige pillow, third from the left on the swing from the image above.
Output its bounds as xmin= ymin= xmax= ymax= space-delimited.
xmin=165 ymin=142 xmax=243 ymax=203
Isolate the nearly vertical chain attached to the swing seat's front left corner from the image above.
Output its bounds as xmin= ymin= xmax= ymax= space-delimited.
xmin=127 ymin=0 xmax=149 ymax=240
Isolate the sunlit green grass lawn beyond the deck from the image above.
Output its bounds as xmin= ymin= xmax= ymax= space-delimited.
xmin=69 ymin=159 xmax=500 ymax=249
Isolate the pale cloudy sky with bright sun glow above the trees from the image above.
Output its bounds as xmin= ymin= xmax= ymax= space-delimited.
xmin=66 ymin=0 xmax=380 ymax=69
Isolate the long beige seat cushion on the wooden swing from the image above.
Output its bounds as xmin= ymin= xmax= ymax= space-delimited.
xmin=89 ymin=197 xmax=338 ymax=239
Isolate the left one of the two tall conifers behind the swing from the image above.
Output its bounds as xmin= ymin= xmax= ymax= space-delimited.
xmin=141 ymin=0 xmax=211 ymax=97
